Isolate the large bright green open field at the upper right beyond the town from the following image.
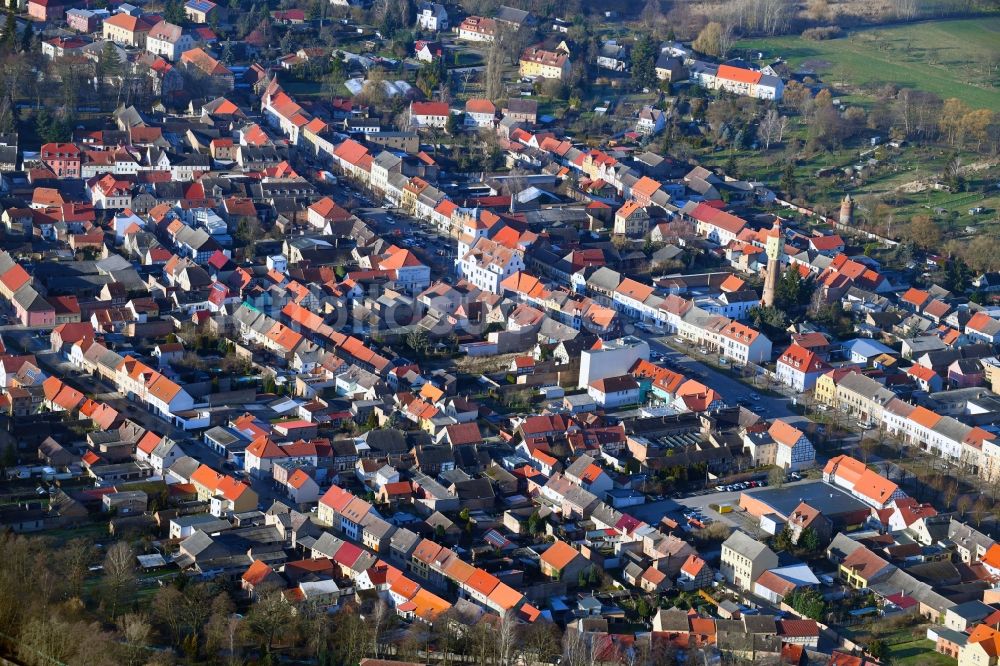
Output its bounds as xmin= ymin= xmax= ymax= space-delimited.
xmin=737 ymin=16 xmax=1000 ymax=109
